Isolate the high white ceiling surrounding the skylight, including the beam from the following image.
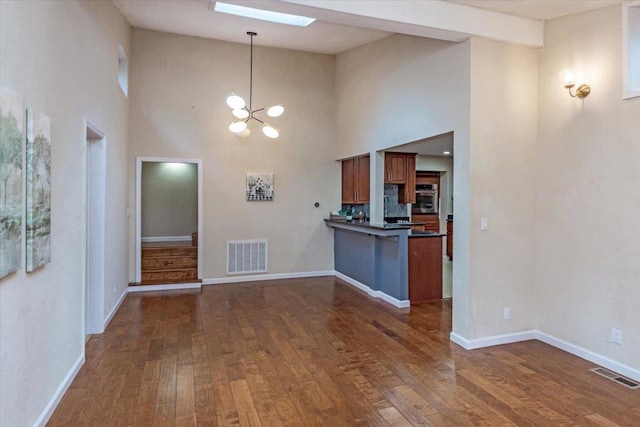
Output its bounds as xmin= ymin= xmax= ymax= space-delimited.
xmin=113 ymin=0 xmax=622 ymax=54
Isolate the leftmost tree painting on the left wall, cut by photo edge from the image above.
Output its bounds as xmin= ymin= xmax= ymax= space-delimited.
xmin=0 ymin=86 xmax=25 ymax=278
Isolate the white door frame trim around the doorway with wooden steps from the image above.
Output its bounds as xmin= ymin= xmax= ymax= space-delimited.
xmin=136 ymin=157 xmax=203 ymax=283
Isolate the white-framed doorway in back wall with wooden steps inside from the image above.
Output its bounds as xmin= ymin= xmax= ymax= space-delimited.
xmin=135 ymin=157 xmax=203 ymax=285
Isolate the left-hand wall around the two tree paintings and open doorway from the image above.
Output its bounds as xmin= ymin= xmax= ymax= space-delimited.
xmin=0 ymin=0 xmax=129 ymax=426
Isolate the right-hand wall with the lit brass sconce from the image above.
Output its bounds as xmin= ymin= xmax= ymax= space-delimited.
xmin=534 ymin=7 xmax=640 ymax=369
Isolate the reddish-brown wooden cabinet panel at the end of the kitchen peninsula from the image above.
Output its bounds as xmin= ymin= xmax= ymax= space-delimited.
xmin=409 ymin=237 xmax=442 ymax=304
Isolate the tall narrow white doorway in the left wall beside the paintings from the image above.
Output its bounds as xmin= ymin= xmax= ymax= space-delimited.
xmin=84 ymin=119 xmax=107 ymax=336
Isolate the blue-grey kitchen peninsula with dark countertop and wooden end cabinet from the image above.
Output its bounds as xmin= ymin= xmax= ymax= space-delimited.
xmin=325 ymin=219 xmax=443 ymax=307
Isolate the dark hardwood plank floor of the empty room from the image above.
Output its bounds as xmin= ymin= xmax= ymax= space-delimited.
xmin=49 ymin=277 xmax=640 ymax=427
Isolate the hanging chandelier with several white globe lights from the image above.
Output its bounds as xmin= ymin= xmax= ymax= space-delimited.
xmin=227 ymin=31 xmax=284 ymax=139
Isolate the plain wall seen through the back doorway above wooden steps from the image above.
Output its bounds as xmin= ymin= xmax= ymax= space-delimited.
xmin=141 ymin=162 xmax=198 ymax=238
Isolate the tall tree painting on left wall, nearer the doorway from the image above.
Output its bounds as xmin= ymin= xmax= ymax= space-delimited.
xmin=26 ymin=109 xmax=51 ymax=272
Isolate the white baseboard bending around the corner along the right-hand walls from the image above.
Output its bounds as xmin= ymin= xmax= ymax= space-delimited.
xmin=450 ymin=330 xmax=640 ymax=381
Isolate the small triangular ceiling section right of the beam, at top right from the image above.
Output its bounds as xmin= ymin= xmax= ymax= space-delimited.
xmin=445 ymin=0 xmax=622 ymax=21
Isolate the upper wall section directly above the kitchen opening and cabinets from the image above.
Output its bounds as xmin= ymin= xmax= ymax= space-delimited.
xmin=335 ymin=34 xmax=469 ymax=159
